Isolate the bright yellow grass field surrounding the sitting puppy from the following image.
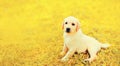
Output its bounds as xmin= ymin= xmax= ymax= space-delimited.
xmin=0 ymin=0 xmax=120 ymax=66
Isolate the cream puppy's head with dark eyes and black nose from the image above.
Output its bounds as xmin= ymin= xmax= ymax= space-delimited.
xmin=62 ymin=16 xmax=80 ymax=33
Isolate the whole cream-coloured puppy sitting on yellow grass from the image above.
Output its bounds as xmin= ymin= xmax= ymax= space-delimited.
xmin=61 ymin=16 xmax=110 ymax=62
